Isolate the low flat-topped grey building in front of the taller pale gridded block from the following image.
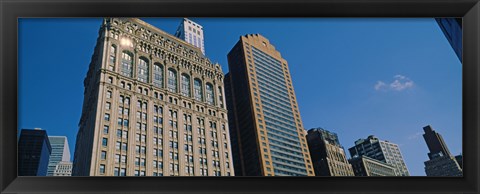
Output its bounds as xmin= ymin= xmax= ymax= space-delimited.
xmin=348 ymin=155 xmax=395 ymax=176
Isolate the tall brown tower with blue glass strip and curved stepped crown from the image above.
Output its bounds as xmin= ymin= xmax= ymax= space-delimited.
xmin=225 ymin=34 xmax=314 ymax=176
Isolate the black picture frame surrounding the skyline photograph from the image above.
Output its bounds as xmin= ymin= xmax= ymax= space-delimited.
xmin=0 ymin=0 xmax=480 ymax=193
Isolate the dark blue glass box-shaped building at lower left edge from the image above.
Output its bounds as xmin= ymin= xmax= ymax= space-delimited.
xmin=18 ymin=128 xmax=52 ymax=176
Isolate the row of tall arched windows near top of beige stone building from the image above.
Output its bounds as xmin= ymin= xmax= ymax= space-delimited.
xmin=108 ymin=45 xmax=223 ymax=107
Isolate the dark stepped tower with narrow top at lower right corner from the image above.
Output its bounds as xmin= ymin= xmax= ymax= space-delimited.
xmin=423 ymin=125 xmax=463 ymax=176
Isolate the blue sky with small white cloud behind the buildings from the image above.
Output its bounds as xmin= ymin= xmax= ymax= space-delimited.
xmin=18 ymin=18 xmax=462 ymax=176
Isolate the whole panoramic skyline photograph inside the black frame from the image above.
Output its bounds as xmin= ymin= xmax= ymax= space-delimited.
xmin=17 ymin=17 xmax=463 ymax=177
